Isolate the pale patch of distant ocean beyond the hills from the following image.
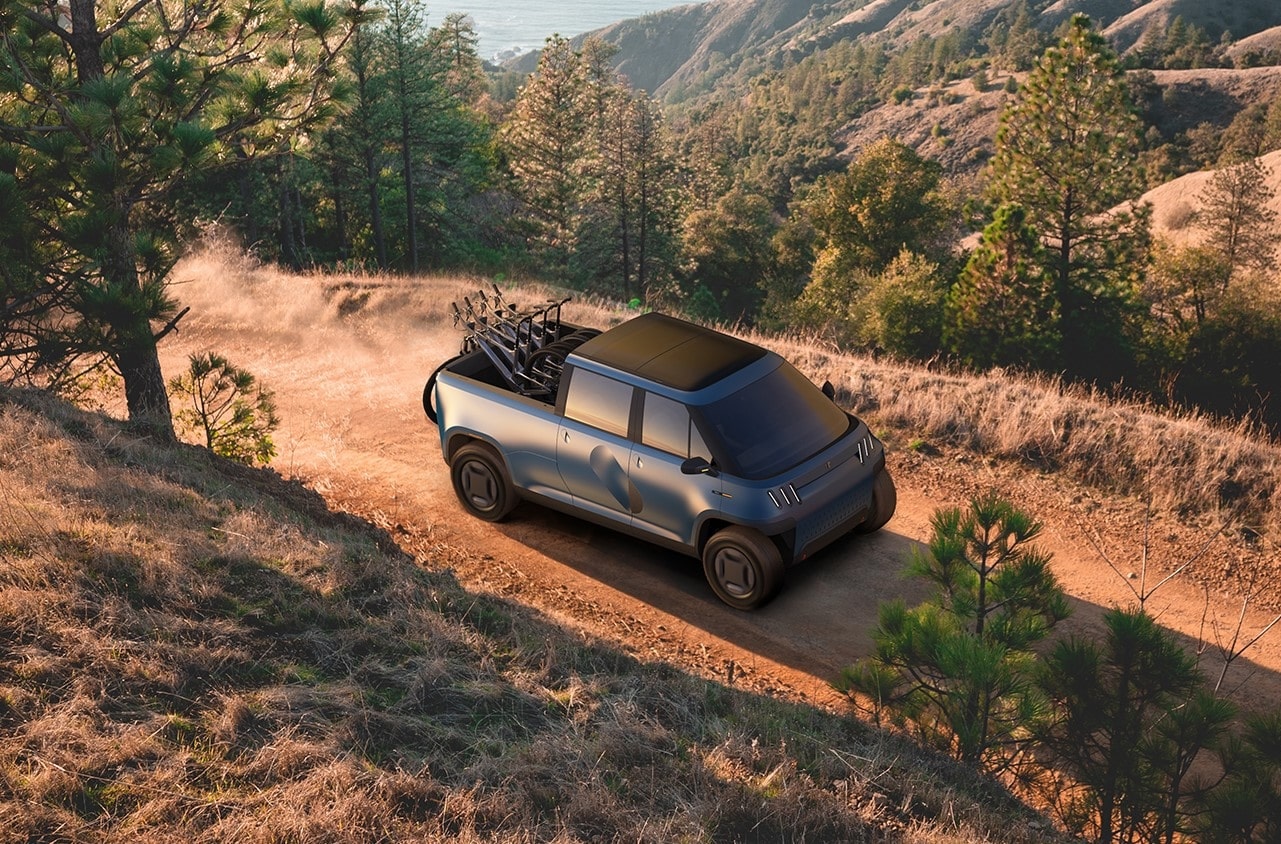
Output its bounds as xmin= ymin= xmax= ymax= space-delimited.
xmin=448 ymin=0 xmax=712 ymax=61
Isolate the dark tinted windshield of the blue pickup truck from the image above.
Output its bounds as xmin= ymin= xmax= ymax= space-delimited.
xmin=701 ymin=361 xmax=849 ymax=480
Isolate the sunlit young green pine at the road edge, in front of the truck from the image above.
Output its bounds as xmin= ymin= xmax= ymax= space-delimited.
xmin=835 ymin=493 xmax=1068 ymax=770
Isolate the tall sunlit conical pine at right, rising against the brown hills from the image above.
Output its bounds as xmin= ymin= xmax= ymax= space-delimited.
xmin=989 ymin=15 xmax=1149 ymax=379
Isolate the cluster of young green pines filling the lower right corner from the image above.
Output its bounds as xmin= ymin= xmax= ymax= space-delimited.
xmin=835 ymin=493 xmax=1281 ymax=844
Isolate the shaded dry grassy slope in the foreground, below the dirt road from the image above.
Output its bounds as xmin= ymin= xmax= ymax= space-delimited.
xmin=0 ymin=391 xmax=1047 ymax=841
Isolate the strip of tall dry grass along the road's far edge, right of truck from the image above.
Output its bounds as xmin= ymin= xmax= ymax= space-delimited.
xmin=757 ymin=338 xmax=1281 ymax=540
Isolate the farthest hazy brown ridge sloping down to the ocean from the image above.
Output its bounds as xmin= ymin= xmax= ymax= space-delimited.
xmin=553 ymin=0 xmax=1281 ymax=100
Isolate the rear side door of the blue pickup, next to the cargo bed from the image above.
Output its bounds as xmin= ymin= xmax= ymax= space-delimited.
xmin=556 ymin=368 xmax=637 ymax=524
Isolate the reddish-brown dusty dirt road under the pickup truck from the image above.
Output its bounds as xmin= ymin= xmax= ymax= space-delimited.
xmin=163 ymin=260 xmax=1281 ymax=707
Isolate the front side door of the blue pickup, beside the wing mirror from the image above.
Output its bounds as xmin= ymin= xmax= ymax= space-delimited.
xmin=628 ymin=392 xmax=721 ymax=547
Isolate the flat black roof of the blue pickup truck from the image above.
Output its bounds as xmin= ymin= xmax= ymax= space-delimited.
xmin=574 ymin=314 xmax=769 ymax=392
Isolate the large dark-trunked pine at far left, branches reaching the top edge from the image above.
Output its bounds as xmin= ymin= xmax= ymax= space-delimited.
xmin=0 ymin=0 xmax=363 ymax=439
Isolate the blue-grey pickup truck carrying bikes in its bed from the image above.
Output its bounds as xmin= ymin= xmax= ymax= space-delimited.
xmin=423 ymin=288 xmax=897 ymax=610
